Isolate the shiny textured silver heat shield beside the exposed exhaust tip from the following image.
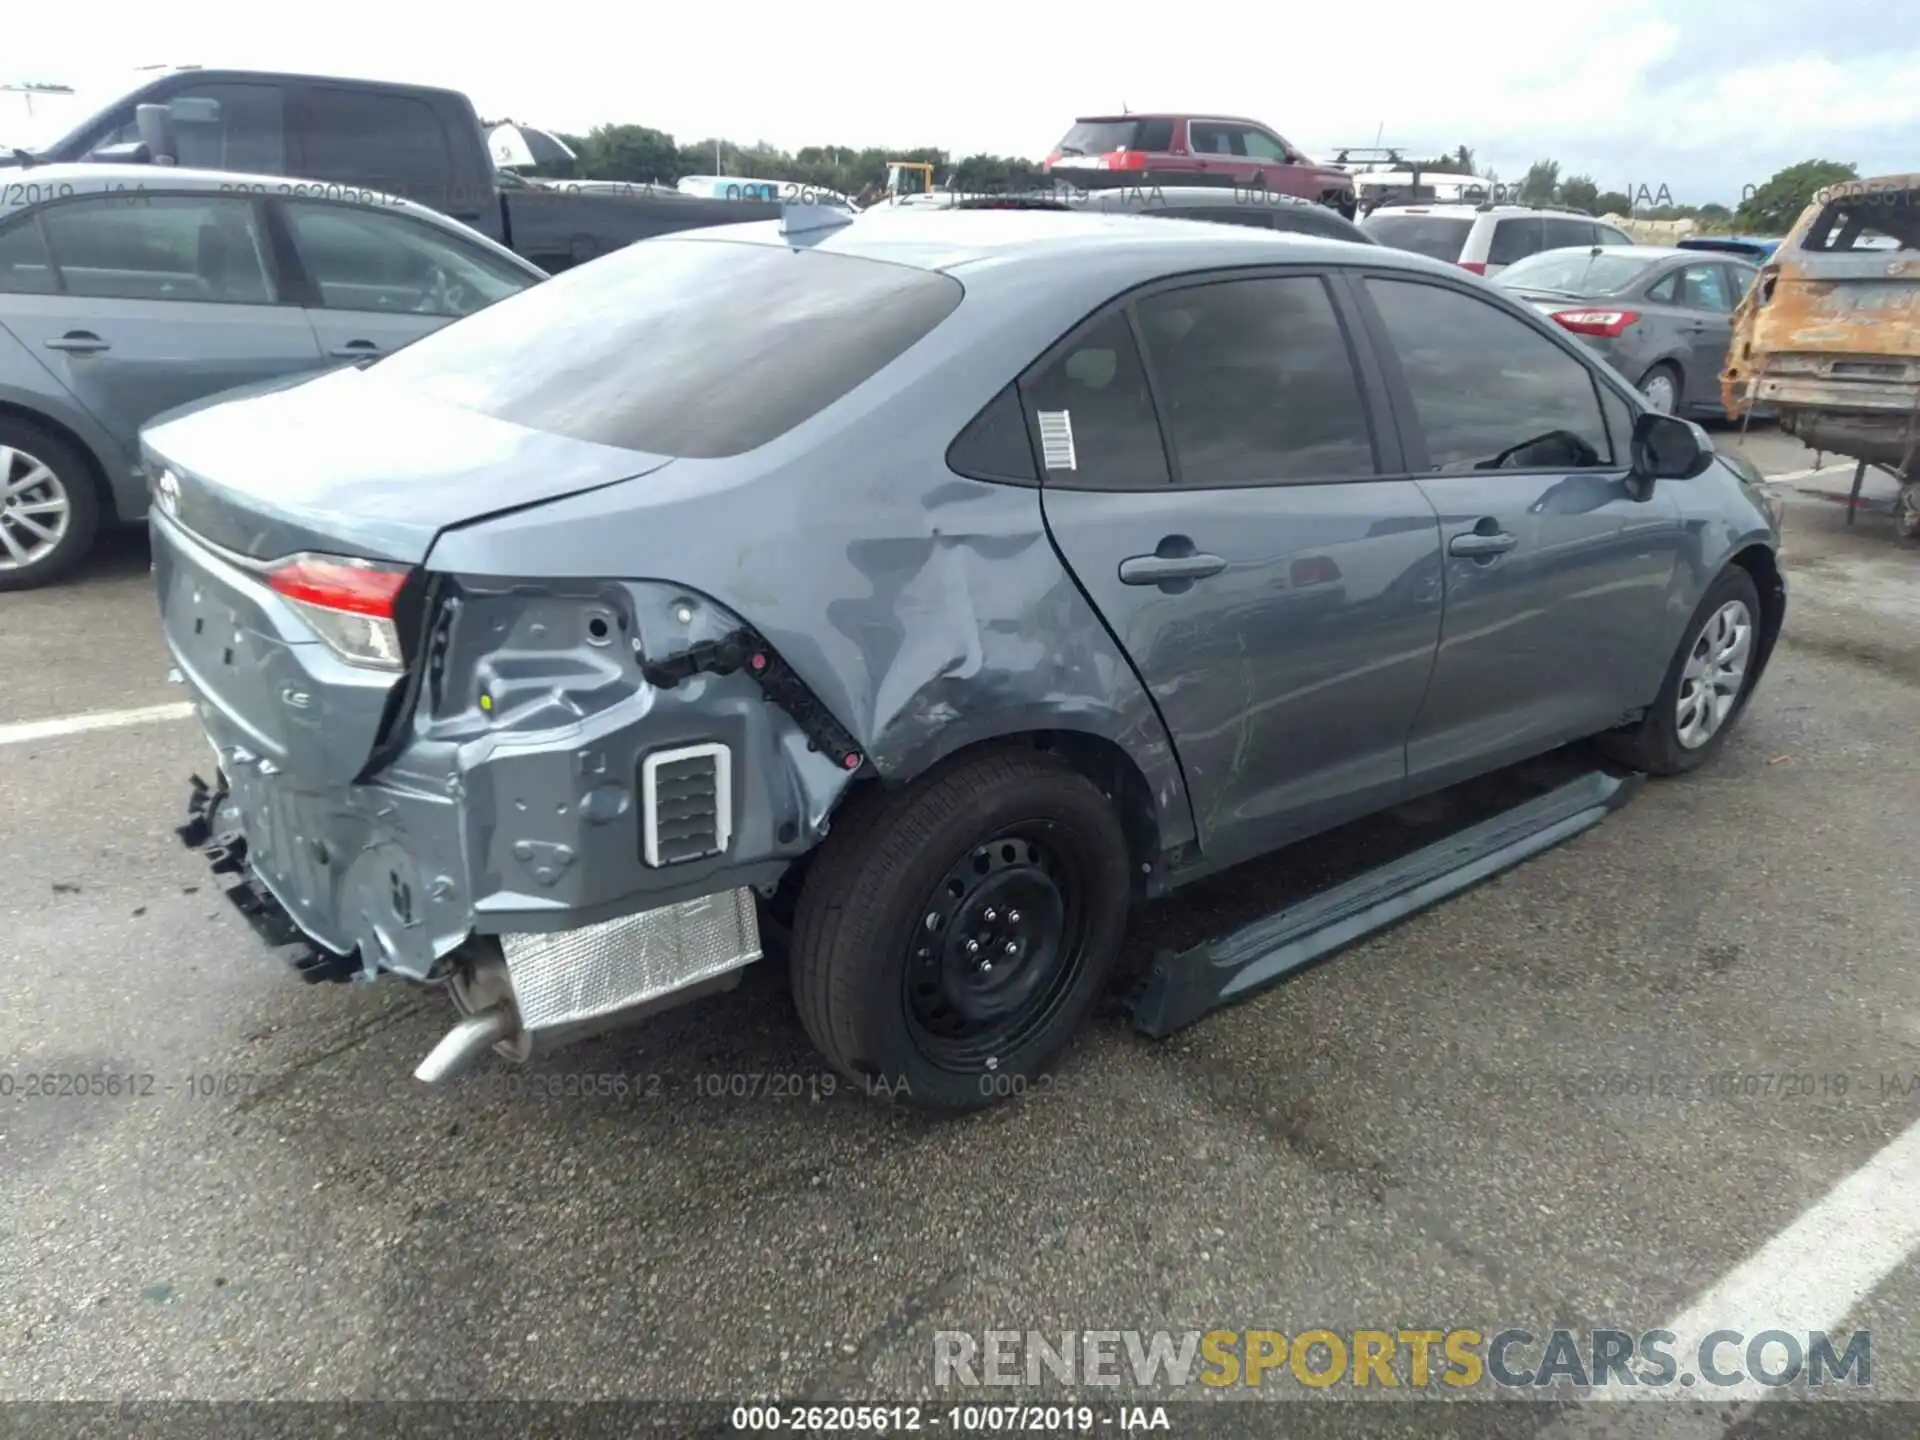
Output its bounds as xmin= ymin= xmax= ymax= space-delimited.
xmin=499 ymin=889 xmax=760 ymax=1031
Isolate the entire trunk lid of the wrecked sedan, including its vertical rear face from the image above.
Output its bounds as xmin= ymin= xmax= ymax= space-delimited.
xmin=142 ymin=369 xmax=668 ymax=791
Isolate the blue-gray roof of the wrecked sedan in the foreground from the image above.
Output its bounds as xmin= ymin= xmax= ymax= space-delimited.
xmin=660 ymin=207 xmax=1428 ymax=280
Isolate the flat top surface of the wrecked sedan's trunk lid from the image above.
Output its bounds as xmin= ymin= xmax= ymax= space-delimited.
xmin=140 ymin=367 xmax=670 ymax=564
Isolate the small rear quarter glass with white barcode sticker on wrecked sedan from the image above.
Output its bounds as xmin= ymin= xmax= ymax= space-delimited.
xmin=1020 ymin=309 xmax=1167 ymax=490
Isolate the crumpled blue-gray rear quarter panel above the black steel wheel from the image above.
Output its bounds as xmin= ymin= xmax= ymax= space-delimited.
xmin=428 ymin=251 xmax=1194 ymax=852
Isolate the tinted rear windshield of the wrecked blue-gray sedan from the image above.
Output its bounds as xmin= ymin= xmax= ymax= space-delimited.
xmin=367 ymin=238 xmax=962 ymax=459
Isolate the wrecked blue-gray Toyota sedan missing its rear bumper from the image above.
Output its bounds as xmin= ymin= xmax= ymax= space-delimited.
xmin=142 ymin=209 xmax=1786 ymax=1110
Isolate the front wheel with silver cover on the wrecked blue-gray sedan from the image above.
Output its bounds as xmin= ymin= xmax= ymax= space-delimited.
xmin=1599 ymin=564 xmax=1764 ymax=776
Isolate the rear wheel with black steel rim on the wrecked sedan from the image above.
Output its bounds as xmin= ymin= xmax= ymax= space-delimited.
xmin=791 ymin=751 xmax=1131 ymax=1112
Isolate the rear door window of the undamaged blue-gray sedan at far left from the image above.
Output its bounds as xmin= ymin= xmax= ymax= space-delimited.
xmin=40 ymin=194 xmax=275 ymax=305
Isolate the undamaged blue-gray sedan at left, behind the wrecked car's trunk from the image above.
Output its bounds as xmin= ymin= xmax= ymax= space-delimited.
xmin=0 ymin=165 xmax=545 ymax=589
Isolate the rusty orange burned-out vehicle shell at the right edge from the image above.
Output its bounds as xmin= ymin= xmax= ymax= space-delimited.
xmin=1720 ymin=175 xmax=1920 ymax=472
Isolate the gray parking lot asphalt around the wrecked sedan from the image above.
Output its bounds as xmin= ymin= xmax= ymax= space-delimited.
xmin=0 ymin=420 xmax=1920 ymax=1432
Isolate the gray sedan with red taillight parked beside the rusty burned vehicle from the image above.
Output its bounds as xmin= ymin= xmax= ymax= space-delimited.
xmin=1494 ymin=246 xmax=1759 ymax=419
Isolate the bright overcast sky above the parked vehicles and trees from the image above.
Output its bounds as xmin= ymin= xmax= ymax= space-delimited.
xmin=0 ymin=0 xmax=1920 ymax=204
